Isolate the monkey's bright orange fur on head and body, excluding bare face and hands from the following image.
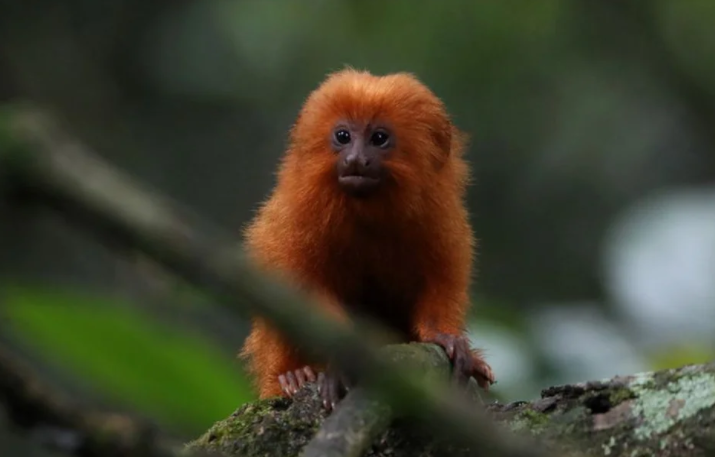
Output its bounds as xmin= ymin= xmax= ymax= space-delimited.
xmin=242 ymin=69 xmax=484 ymax=398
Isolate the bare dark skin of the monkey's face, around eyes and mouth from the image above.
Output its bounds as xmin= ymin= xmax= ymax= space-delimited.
xmin=331 ymin=122 xmax=395 ymax=198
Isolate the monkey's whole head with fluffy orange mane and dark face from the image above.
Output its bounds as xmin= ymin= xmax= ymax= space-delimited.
xmin=281 ymin=70 xmax=456 ymax=211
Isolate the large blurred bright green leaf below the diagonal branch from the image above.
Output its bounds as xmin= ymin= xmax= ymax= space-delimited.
xmin=4 ymin=288 xmax=253 ymax=433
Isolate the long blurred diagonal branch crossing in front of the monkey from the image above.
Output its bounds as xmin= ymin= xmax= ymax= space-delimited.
xmin=0 ymin=109 xmax=543 ymax=457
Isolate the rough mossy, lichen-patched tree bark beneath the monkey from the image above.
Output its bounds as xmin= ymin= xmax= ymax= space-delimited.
xmin=188 ymin=356 xmax=715 ymax=457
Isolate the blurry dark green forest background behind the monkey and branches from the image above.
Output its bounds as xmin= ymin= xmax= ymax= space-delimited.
xmin=0 ymin=0 xmax=715 ymax=453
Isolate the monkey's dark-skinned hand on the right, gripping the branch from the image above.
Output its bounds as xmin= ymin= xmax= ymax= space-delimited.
xmin=425 ymin=333 xmax=494 ymax=390
